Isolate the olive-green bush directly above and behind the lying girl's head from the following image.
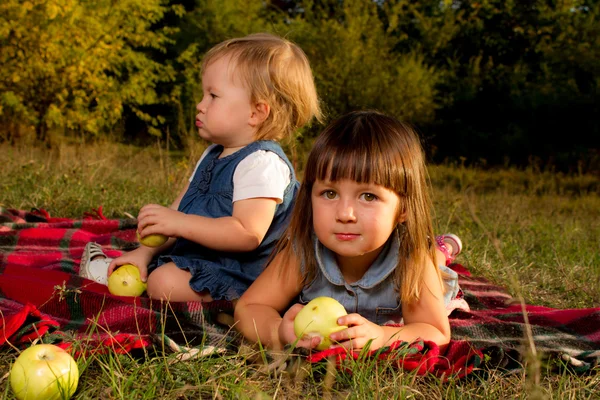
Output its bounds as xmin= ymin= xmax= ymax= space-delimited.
xmin=280 ymin=0 xmax=439 ymax=123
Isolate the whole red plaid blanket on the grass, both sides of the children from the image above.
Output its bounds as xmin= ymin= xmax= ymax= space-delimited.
xmin=0 ymin=207 xmax=600 ymax=376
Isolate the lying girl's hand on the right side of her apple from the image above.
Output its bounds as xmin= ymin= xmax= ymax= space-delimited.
xmin=329 ymin=314 xmax=385 ymax=350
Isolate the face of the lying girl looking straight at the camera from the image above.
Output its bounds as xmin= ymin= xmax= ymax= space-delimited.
xmin=311 ymin=179 xmax=401 ymax=268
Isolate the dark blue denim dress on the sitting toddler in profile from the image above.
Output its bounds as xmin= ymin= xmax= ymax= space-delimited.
xmin=156 ymin=140 xmax=299 ymax=300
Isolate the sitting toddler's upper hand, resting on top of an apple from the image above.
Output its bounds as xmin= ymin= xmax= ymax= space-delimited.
xmin=138 ymin=204 xmax=185 ymax=237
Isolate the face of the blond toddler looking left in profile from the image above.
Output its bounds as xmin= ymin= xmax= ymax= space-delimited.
xmin=196 ymin=57 xmax=255 ymax=148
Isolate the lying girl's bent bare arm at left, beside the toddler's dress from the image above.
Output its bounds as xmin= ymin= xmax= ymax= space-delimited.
xmin=234 ymin=253 xmax=302 ymax=349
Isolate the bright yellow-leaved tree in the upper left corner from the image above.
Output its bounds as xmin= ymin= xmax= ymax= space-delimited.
xmin=0 ymin=0 xmax=179 ymax=141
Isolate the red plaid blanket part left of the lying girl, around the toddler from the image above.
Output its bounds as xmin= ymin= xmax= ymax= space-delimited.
xmin=0 ymin=207 xmax=233 ymax=352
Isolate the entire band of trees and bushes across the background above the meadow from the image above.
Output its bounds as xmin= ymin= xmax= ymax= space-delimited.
xmin=0 ymin=0 xmax=600 ymax=172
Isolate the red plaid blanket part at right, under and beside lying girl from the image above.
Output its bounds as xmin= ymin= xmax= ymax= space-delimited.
xmin=308 ymin=264 xmax=600 ymax=377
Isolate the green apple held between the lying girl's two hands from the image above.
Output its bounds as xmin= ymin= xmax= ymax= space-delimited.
xmin=294 ymin=296 xmax=348 ymax=350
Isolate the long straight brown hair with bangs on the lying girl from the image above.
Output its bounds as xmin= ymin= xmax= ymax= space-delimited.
xmin=277 ymin=111 xmax=440 ymax=304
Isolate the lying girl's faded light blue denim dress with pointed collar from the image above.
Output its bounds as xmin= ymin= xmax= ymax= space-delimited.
xmin=299 ymin=233 xmax=459 ymax=325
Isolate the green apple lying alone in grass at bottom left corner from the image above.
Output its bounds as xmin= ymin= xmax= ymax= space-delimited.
xmin=10 ymin=344 xmax=79 ymax=400
